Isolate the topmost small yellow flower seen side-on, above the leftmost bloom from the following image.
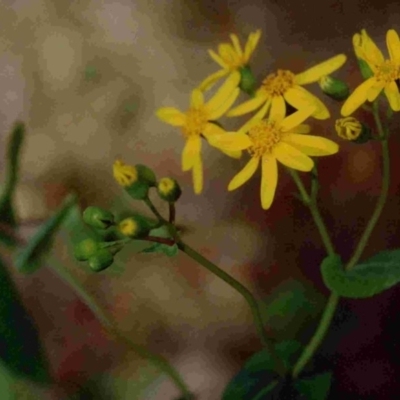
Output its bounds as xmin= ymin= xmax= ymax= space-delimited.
xmin=199 ymin=30 xmax=261 ymax=91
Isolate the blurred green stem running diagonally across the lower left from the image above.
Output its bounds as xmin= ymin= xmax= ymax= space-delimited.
xmin=52 ymin=263 xmax=192 ymax=398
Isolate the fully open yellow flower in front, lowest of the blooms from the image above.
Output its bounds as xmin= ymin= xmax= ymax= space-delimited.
xmin=212 ymin=104 xmax=338 ymax=210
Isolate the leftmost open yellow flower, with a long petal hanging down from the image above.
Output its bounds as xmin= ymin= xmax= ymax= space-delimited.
xmin=156 ymin=72 xmax=240 ymax=193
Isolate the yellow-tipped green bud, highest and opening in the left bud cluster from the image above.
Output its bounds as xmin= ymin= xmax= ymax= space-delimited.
xmin=113 ymin=160 xmax=150 ymax=200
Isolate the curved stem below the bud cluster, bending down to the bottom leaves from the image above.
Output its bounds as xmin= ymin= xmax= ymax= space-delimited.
xmin=177 ymin=240 xmax=286 ymax=376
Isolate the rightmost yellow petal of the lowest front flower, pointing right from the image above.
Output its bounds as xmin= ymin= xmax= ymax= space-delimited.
xmin=282 ymin=133 xmax=339 ymax=156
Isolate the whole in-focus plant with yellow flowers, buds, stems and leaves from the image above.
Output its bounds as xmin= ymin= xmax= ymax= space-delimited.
xmin=76 ymin=29 xmax=400 ymax=400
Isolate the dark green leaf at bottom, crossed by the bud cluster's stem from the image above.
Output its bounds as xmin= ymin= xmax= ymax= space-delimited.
xmin=222 ymin=340 xmax=301 ymax=400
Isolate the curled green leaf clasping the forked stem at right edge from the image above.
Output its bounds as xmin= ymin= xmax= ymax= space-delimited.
xmin=321 ymin=250 xmax=400 ymax=299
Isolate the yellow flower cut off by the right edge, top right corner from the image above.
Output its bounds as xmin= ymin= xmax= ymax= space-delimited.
xmin=341 ymin=29 xmax=400 ymax=117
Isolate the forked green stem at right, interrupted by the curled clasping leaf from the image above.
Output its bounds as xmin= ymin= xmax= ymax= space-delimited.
xmin=292 ymin=107 xmax=390 ymax=378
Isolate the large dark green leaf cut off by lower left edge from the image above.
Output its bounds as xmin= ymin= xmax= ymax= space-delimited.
xmin=0 ymin=255 xmax=51 ymax=383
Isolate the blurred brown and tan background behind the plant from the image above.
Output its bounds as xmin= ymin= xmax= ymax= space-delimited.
xmin=0 ymin=0 xmax=400 ymax=400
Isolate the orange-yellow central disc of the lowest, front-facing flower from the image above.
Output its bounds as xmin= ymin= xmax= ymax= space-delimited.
xmin=248 ymin=120 xmax=283 ymax=157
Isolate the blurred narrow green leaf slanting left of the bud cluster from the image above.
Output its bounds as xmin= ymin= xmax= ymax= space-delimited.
xmin=15 ymin=195 xmax=76 ymax=273
